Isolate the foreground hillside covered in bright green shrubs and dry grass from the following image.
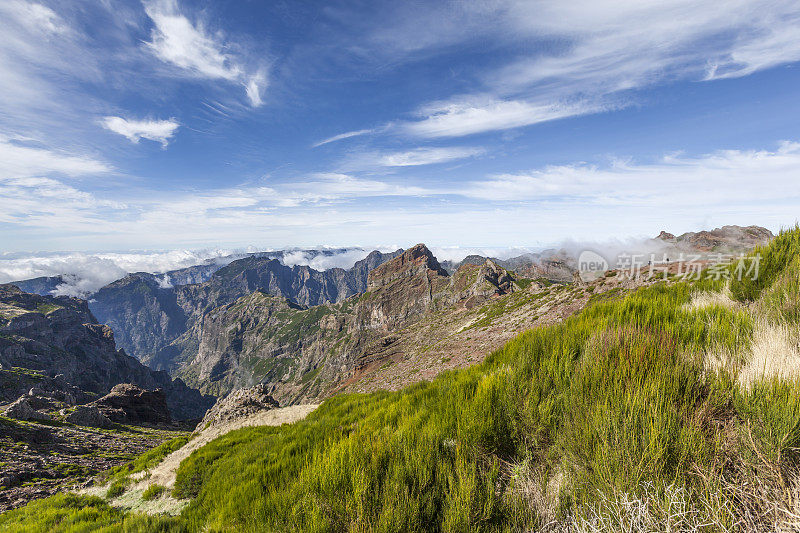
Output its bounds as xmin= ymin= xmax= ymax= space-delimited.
xmin=0 ymin=228 xmax=800 ymax=531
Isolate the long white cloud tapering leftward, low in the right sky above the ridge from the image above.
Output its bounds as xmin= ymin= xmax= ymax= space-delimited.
xmin=462 ymin=142 xmax=800 ymax=208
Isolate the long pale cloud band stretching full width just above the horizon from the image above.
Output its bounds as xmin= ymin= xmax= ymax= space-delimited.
xmin=0 ymin=137 xmax=800 ymax=250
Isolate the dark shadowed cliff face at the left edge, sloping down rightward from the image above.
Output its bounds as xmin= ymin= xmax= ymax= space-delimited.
xmin=0 ymin=285 xmax=213 ymax=419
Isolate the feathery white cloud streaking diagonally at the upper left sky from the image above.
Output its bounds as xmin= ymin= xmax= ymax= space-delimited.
xmin=144 ymin=0 xmax=267 ymax=107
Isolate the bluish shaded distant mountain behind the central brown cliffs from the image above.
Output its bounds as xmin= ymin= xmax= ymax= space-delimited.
xmin=90 ymin=250 xmax=401 ymax=369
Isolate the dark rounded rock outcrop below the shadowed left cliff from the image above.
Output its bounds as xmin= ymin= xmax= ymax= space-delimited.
xmin=89 ymin=383 xmax=172 ymax=425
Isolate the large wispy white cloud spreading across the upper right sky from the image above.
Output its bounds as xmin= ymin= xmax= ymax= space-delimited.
xmin=388 ymin=0 xmax=800 ymax=138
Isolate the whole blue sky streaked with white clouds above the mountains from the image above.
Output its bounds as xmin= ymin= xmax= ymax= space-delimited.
xmin=0 ymin=0 xmax=800 ymax=252
